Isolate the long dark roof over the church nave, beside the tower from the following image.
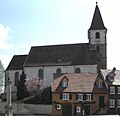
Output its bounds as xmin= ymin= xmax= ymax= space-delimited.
xmin=24 ymin=43 xmax=97 ymax=67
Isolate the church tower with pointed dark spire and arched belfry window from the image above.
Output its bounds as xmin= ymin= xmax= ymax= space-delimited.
xmin=88 ymin=3 xmax=107 ymax=69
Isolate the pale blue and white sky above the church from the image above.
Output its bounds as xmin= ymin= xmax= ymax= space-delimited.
xmin=0 ymin=0 xmax=120 ymax=70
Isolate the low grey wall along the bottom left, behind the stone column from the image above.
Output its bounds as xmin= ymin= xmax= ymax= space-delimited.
xmin=0 ymin=102 xmax=52 ymax=116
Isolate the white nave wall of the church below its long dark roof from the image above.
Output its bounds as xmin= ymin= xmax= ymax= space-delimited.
xmin=24 ymin=65 xmax=97 ymax=86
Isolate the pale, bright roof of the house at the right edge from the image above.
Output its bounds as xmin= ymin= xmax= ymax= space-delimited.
xmin=101 ymin=69 xmax=120 ymax=85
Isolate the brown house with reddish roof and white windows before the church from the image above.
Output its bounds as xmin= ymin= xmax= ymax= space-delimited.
xmin=51 ymin=73 xmax=108 ymax=116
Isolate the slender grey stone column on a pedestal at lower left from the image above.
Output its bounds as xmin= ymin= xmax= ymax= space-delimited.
xmin=5 ymin=73 xmax=13 ymax=116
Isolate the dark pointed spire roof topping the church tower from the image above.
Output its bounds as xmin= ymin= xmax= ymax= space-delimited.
xmin=89 ymin=3 xmax=106 ymax=30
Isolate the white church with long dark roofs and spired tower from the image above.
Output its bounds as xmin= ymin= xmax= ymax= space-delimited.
xmin=6 ymin=4 xmax=107 ymax=99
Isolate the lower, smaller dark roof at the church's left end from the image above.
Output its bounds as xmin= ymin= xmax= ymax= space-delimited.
xmin=6 ymin=55 xmax=27 ymax=70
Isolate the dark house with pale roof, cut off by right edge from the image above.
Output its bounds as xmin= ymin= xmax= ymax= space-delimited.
xmin=102 ymin=69 xmax=120 ymax=114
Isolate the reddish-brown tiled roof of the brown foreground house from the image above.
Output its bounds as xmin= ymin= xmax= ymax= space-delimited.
xmin=52 ymin=73 xmax=98 ymax=93
